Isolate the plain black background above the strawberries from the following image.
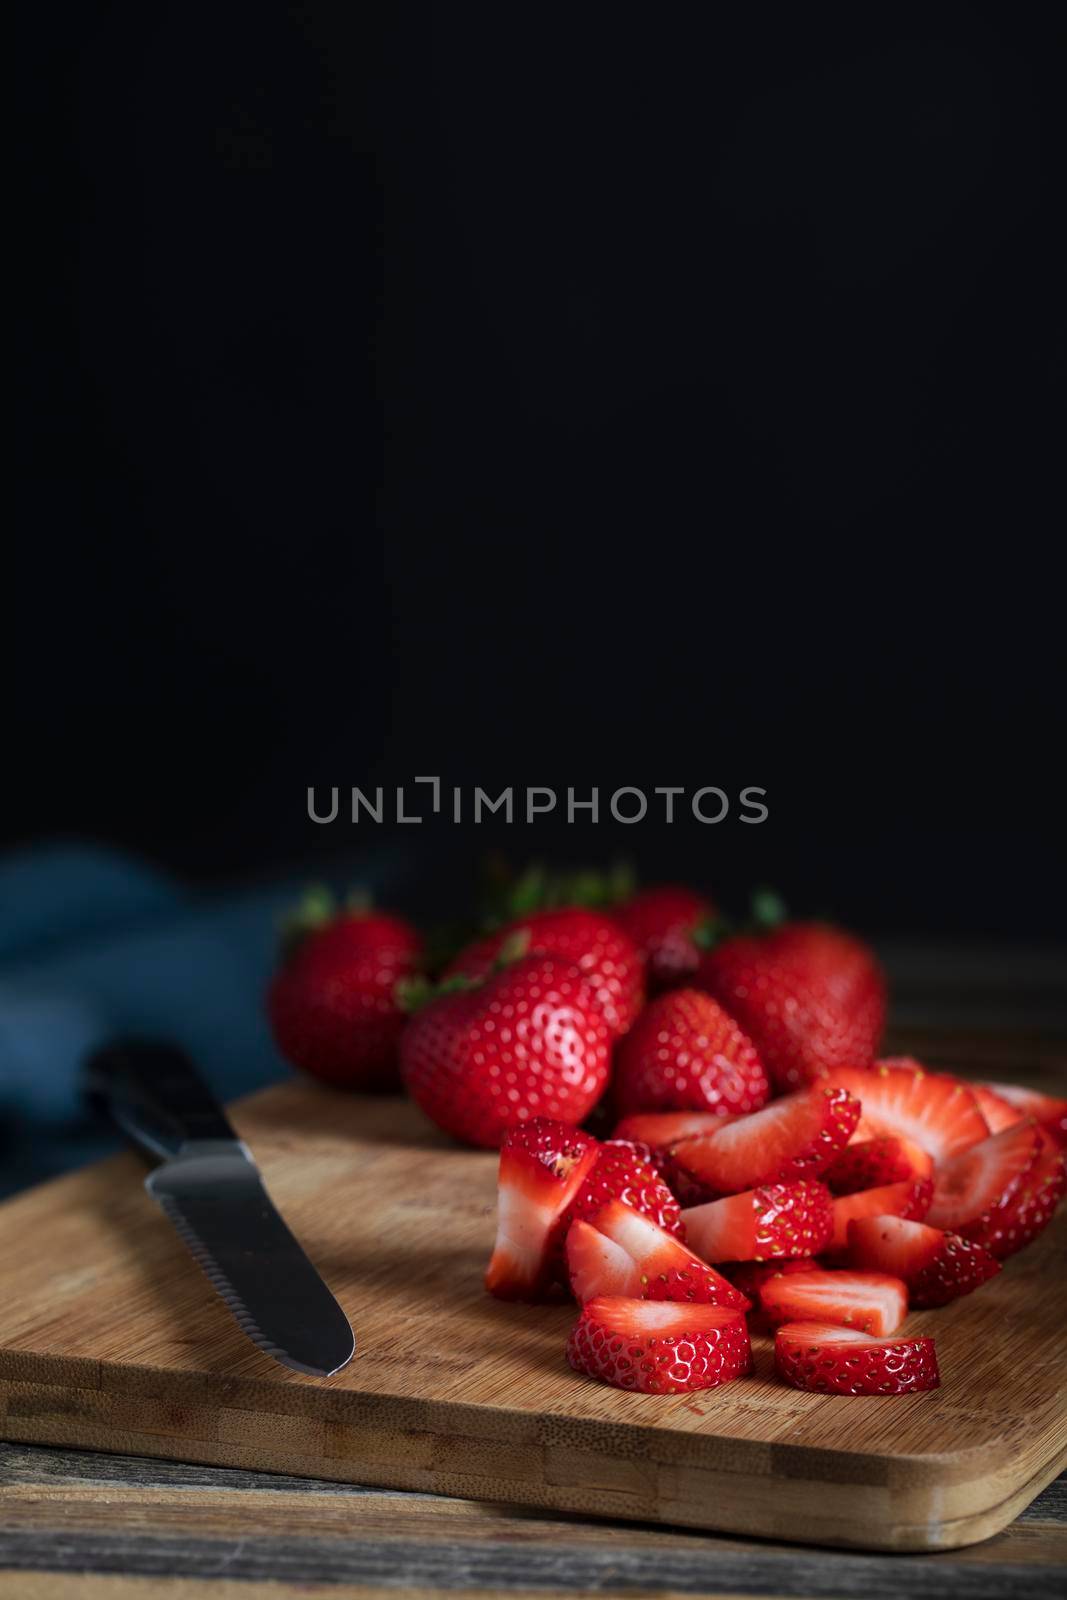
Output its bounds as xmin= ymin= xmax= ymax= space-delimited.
xmin=12 ymin=0 xmax=1064 ymax=936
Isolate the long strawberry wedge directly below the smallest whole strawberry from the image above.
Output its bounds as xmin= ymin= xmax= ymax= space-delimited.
xmin=670 ymin=1083 xmax=859 ymax=1195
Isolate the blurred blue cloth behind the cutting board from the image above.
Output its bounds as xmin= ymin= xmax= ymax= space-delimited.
xmin=0 ymin=846 xmax=403 ymax=1194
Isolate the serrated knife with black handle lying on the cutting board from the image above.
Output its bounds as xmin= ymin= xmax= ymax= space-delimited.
xmin=86 ymin=1038 xmax=355 ymax=1378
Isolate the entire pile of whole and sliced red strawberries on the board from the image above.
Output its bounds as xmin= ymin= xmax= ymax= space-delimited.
xmin=269 ymin=888 xmax=1067 ymax=1395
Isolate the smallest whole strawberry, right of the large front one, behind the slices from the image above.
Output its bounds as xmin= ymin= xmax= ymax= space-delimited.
xmin=614 ymin=989 xmax=771 ymax=1114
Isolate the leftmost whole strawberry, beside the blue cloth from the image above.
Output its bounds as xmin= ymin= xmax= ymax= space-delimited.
xmin=267 ymin=907 xmax=422 ymax=1090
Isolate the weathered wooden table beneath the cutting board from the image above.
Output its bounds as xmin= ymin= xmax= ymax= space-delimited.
xmin=0 ymin=962 xmax=1067 ymax=1600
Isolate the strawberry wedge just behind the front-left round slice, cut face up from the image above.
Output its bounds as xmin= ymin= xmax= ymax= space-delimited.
xmin=566 ymin=1200 xmax=749 ymax=1310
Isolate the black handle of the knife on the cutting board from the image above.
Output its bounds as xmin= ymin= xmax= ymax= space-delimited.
xmin=85 ymin=1038 xmax=237 ymax=1158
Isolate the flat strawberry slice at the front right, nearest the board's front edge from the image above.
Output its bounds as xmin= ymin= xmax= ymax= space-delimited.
xmin=774 ymin=1322 xmax=941 ymax=1395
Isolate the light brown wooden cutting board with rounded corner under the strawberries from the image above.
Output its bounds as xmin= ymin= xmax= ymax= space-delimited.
xmin=0 ymin=1083 xmax=1067 ymax=1550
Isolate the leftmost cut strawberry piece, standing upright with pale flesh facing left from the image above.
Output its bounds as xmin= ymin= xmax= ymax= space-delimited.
xmin=485 ymin=1117 xmax=598 ymax=1299
